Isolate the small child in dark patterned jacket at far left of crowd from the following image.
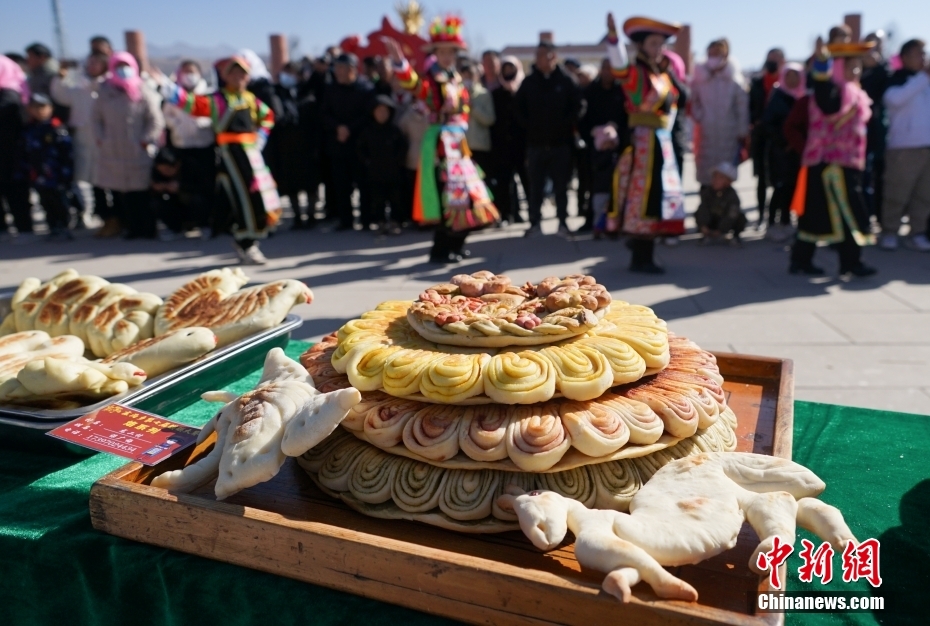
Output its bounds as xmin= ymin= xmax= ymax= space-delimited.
xmin=21 ymin=93 xmax=74 ymax=240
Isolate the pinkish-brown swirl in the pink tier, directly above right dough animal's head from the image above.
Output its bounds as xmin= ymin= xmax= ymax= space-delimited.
xmin=507 ymin=404 xmax=572 ymax=472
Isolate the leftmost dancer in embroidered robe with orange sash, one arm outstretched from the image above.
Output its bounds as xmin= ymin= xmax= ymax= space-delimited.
xmin=162 ymin=56 xmax=281 ymax=265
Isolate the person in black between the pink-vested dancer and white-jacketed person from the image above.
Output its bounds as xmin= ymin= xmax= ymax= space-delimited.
xmin=861 ymin=31 xmax=891 ymax=224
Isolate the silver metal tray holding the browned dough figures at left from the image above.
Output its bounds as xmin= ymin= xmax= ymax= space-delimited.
xmin=0 ymin=314 xmax=303 ymax=422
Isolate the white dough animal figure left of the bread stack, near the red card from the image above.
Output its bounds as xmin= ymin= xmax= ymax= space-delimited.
xmin=152 ymin=348 xmax=362 ymax=500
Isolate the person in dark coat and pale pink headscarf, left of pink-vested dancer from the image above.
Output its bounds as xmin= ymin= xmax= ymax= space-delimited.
xmin=759 ymin=63 xmax=807 ymax=241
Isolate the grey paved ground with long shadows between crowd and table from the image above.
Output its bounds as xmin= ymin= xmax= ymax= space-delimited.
xmin=0 ymin=156 xmax=930 ymax=414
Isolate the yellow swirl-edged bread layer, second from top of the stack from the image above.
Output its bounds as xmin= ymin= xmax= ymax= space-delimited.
xmin=323 ymin=302 xmax=670 ymax=405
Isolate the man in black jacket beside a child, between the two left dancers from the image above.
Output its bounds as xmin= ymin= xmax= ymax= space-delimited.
xmin=322 ymin=54 xmax=372 ymax=230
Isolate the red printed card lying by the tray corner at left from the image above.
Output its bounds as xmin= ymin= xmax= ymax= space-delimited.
xmin=48 ymin=404 xmax=200 ymax=465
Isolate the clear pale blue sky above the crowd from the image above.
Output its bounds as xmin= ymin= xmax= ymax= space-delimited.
xmin=0 ymin=0 xmax=930 ymax=66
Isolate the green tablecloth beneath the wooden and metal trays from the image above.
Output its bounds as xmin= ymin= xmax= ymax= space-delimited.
xmin=0 ymin=342 xmax=930 ymax=626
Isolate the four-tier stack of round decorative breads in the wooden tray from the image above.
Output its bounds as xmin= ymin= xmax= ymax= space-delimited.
xmin=299 ymin=272 xmax=736 ymax=532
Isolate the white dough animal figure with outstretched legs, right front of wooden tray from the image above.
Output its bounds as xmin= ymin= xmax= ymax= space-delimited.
xmin=497 ymin=452 xmax=856 ymax=602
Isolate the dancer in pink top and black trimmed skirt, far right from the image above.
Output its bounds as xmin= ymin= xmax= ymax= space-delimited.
xmin=785 ymin=38 xmax=876 ymax=277
